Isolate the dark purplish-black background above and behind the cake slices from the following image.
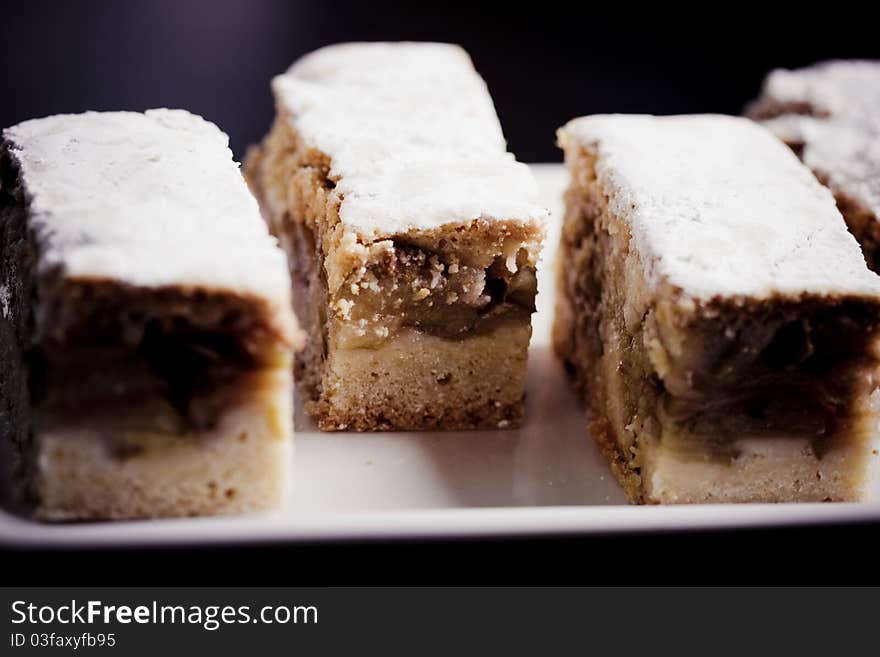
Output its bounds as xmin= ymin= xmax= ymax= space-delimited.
xmin=0 ymin=0 xmax=880 ymax=161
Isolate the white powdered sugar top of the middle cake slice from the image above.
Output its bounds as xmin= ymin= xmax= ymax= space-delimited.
xmin=272 ymin=43 xmax=546 ymax=239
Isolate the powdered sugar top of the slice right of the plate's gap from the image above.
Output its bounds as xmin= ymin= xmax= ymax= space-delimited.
xmin=559 ymin=115 xmax=880 ymax=299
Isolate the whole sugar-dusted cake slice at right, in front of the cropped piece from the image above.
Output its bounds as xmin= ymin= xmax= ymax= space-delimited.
xmin=553 ymin=115 xmax=880 ymax=503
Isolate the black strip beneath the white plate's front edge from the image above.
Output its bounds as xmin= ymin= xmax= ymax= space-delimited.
xmin=0 ymin=524 xmax=880 ymax=584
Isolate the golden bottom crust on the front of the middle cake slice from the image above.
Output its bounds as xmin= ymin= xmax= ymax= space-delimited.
xmin=307 ymin=320 xmax=531 ymax=431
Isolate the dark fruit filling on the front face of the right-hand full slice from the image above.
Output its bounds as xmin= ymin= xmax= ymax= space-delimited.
xmin=646 ymin=302 xmax=878 ymax=459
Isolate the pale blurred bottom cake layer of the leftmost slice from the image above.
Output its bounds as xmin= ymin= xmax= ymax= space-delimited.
xmin=34 ymin=369 xmax=293 ymax=520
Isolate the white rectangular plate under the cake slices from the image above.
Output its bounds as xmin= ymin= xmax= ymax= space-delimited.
xmin=0 ymin=164 xmax=880 ymax=547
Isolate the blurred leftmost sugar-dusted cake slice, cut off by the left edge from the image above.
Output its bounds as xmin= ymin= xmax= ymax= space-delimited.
xmin=0 ymin=109 xmax=301 ymax=520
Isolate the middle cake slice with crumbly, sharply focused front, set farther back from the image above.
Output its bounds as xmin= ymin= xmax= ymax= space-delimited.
xmin=245 ymin=43 xmax=546 ymax=431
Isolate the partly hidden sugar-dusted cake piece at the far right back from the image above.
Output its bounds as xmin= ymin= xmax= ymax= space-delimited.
xmin=747 ymin=61 xmax=880 ymax=271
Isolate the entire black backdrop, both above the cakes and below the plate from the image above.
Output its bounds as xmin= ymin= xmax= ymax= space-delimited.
xmin=0 ymin=0 xmax=880 ymax=585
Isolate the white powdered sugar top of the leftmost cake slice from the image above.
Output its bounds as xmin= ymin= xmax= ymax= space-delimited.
xmin=3 ymin=109 xmax=290 ymax=313
